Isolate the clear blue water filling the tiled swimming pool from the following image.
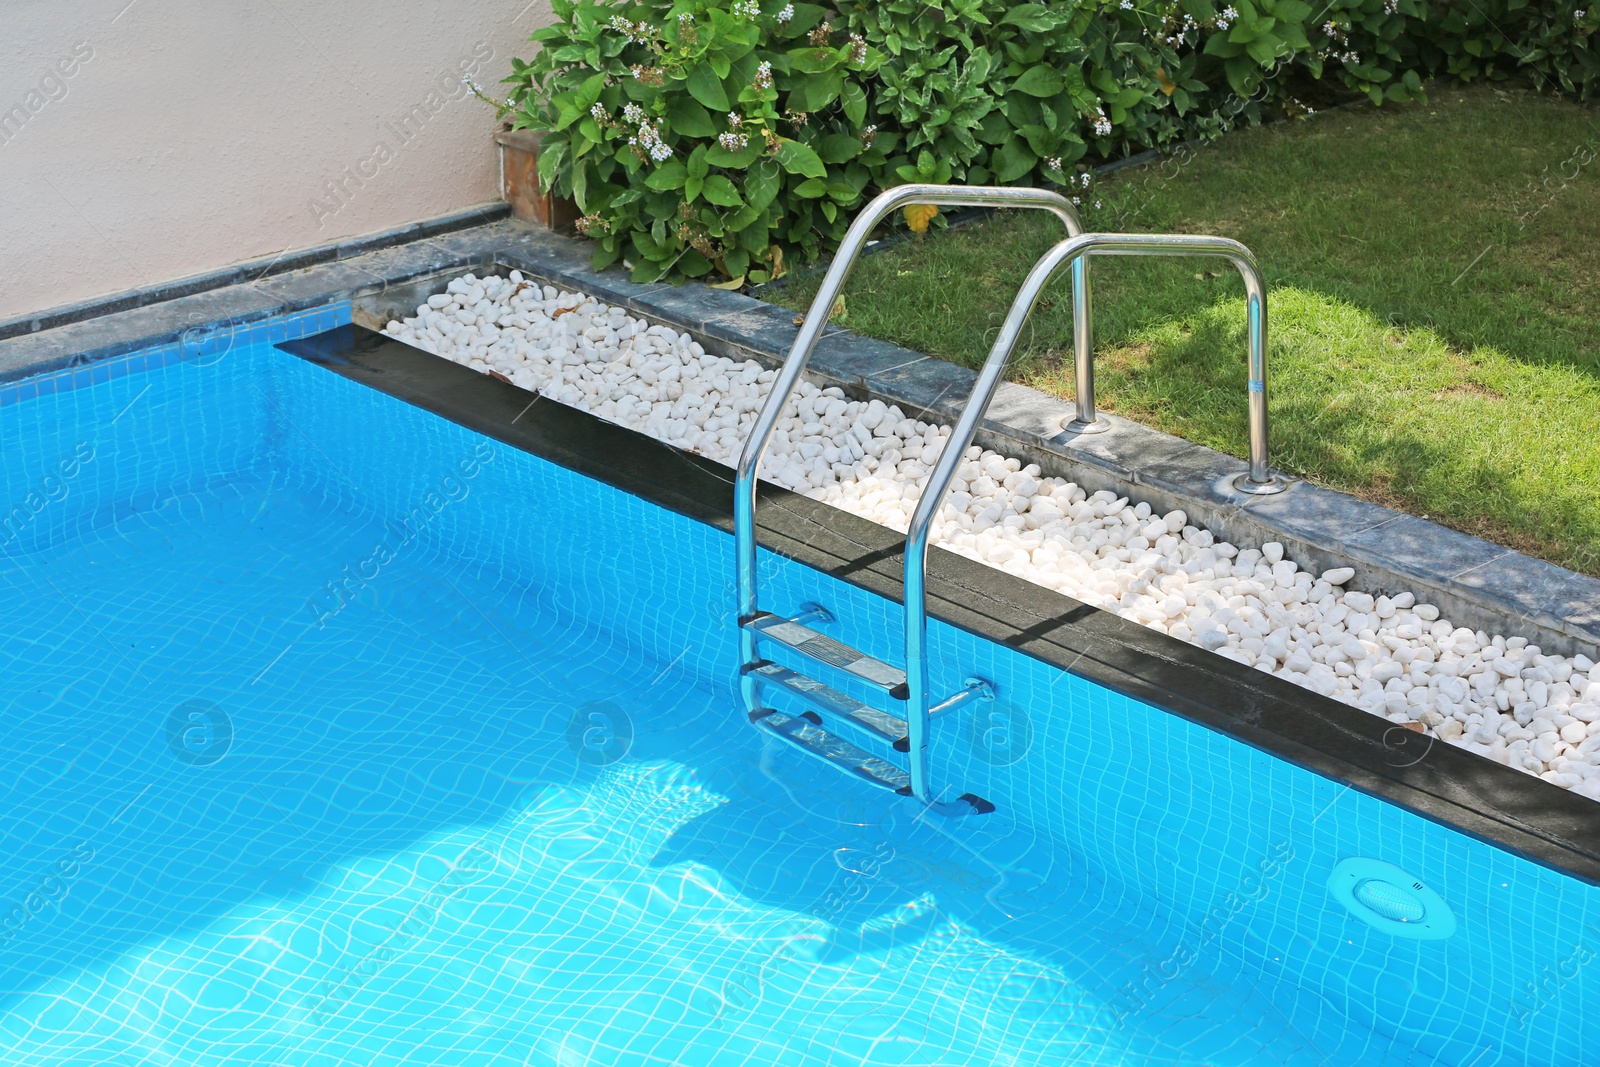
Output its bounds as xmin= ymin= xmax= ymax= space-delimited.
xmin=0 ymin=303 xmax=1600 ymax=1067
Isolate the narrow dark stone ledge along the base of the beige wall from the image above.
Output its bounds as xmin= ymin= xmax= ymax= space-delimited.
xmin=0 ymin=202 xmax=510 ymax=341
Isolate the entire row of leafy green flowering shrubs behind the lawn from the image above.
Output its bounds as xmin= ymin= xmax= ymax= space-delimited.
xmin=507 ymin=0 xmax=1600 ymax=283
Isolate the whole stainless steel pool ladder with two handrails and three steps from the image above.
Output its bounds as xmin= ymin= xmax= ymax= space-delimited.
xmin=734 ymin=186 xmax=1285 ymax=814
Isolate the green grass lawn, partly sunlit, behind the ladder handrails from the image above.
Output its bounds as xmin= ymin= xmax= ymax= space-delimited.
xmin=768 ymin=86 xmax=1600 ymax=574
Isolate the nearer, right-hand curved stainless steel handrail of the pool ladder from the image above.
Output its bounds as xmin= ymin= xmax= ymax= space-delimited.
xmin=906 ymin=234 xmax=1286 ymax=806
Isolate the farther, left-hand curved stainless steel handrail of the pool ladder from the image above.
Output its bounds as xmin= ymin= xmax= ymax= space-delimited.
xmin=733 ymin=186 xmax=1091 ymax=735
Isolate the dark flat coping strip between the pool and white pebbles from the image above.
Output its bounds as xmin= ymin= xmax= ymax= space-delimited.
xmin=278 ymin=326 xmax=1600 ymax=885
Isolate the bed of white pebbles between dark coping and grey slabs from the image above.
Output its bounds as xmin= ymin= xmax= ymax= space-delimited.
xmin=386 ymin=270 xmax=1600 ymax=800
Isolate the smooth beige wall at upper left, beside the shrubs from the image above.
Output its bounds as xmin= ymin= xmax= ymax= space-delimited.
xmin=0 ymin=0 xmax=550 ymax=317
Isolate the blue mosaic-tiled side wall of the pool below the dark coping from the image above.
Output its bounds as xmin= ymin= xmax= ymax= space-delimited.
xmin=0 ymin=319 xmax=1600 ymax=1067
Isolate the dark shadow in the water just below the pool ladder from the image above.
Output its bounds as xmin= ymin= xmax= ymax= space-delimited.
xmin=651 ymin=742 xmax=1139 ymax=995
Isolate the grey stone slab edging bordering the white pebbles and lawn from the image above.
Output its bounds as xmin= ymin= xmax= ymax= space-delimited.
xmin=0 ymin=219 xmax=1600 ymax=657
